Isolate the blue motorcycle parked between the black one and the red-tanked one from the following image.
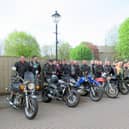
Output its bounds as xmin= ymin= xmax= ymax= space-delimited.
xmin=70 ymin=75 xmax=103 ymax=101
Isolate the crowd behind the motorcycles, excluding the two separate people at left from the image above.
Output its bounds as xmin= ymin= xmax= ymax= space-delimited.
xmin=43 ymin=60 xmax=129 ymax=79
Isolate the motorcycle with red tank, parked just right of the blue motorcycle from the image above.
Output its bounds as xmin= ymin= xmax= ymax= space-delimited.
xmin=95 ymin=73 xmax=119 ymax=98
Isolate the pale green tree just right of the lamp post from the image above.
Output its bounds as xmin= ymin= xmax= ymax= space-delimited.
xmin=58 ymin=42 xmax=71 ymax=60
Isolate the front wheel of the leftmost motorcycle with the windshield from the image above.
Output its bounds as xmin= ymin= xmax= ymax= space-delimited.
xmin=24 ymin=97 xmax=38 ymax=120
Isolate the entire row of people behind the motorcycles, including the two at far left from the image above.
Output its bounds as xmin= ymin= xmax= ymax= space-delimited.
xmin=15 ymin=56 xmax=129 ymax=81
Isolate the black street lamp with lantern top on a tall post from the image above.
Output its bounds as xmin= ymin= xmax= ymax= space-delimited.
xmin=52 ymin=11 xmax=61 ymax=60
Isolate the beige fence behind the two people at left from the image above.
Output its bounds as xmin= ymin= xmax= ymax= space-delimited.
xmin=0 ymin=57 xmax=45 ymax=93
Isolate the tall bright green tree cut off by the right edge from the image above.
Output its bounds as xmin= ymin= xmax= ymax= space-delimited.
xmin=116 ymin=18 xmax=129 ymax=59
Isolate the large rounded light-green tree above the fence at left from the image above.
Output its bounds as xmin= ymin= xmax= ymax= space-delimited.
xmin=4 ymin=31 xmax=40 ymax=57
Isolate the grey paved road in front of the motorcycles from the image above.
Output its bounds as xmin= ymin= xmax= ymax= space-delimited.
xmin=0 ymin=95 xmax=129 ymax=129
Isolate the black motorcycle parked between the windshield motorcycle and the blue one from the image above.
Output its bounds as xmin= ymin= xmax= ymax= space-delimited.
xmin=42 ymin=75 xmax=80 ymax=107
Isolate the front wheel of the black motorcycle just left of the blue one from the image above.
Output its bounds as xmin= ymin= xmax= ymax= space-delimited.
xmin=64 ymin=89 xmax=80 ymax=107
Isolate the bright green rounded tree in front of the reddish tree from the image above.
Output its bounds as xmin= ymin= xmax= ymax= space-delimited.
xmin=70 ymin=43 xmax=93 ymax=60
